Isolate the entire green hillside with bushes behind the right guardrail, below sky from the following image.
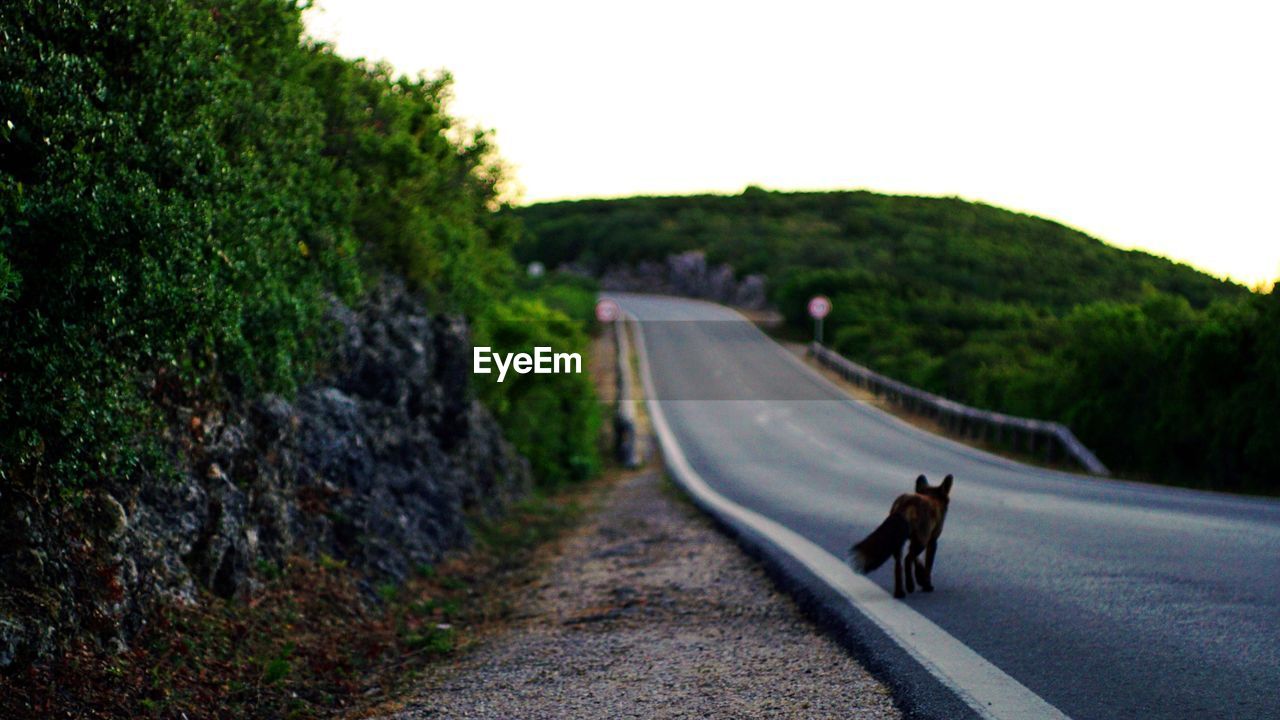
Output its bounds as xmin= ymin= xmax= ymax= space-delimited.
xmin=515 ymin=188 xmax=1280 ymax=492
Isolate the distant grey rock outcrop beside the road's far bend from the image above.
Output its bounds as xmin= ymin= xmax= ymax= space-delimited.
xmin=600 ymin=250 xmax=768 ymax=310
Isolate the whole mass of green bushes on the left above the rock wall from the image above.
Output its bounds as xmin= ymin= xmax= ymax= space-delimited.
xmin=0 ymin=0 xmax=598 ymax=496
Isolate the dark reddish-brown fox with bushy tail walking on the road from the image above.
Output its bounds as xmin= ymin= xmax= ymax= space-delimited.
xmin=849 ymin=475 xmax=952 ymax=598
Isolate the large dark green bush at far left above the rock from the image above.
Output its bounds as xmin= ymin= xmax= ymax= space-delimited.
xmin=0 ymin=0 xmax=356 ymax=487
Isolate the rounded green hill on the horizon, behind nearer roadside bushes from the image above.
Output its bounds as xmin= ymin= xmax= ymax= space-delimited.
xmin=518 ymin=188 xmax=1244 ymax=311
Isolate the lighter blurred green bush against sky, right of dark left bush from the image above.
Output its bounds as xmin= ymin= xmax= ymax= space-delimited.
xmin=300 ymin=46 xmax=517 ymax=314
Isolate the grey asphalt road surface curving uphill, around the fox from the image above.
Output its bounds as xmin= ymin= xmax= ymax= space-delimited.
xmin=611 ymin=293 xmax=1280 ymax=720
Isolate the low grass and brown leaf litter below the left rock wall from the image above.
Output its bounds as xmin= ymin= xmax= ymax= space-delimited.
xmin=0 ymin=312 xmax=617 ymax=720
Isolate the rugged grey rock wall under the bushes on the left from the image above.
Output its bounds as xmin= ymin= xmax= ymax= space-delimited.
xmin=0 ymin=275 xmax=530 ymax=667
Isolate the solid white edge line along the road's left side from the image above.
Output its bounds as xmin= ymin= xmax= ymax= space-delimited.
xmin=627 ymin=314 xmax=1066 ymax=720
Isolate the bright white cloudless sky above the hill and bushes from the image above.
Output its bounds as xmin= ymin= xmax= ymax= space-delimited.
xmin=307 ymin=0 xmax=1280 ymax=286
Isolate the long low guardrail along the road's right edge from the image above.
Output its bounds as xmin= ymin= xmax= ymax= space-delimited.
xmin=809 ymin=342 xmax=1111 ymax=475
